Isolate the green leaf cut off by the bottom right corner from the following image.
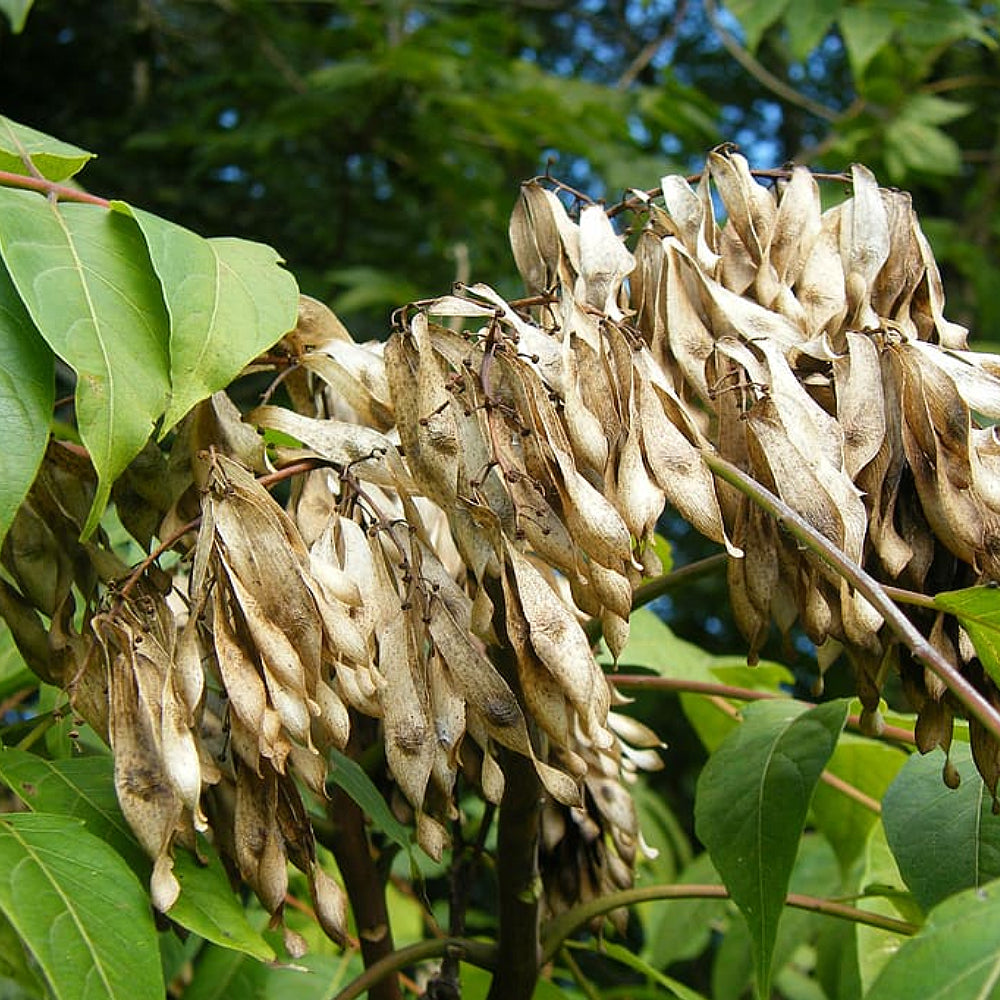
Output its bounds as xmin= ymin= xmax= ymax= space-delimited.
xmin=867 ymin=882 xmax=1000 ymax=1000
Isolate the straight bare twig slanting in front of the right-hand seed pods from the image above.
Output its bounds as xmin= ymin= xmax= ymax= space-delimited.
xmin=702 ymin=451 xmax=1000 ymax=740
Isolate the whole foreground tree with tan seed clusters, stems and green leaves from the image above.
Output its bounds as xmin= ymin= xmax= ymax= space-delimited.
xmin=0 ymin=5 xmax=1000 ymax=997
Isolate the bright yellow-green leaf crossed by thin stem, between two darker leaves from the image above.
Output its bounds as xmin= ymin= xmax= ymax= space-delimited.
xmin=812 ymin=733 xmax=912 ymax=873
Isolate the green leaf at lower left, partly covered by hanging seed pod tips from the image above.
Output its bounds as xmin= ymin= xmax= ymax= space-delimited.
xmin=0 ymin=747 xmax=274 ymax=962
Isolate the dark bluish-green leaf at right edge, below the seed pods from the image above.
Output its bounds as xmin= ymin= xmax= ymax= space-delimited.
xmin=882 ymin=744 xmax=1000 ymax=910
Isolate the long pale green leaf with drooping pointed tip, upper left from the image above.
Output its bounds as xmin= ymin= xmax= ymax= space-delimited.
xmin=0 ymin=188 xmax=169 ymax=538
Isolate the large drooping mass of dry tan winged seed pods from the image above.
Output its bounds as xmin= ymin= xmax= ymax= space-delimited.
xmin=84 ymin=149 xmax=1000 ymax=938
